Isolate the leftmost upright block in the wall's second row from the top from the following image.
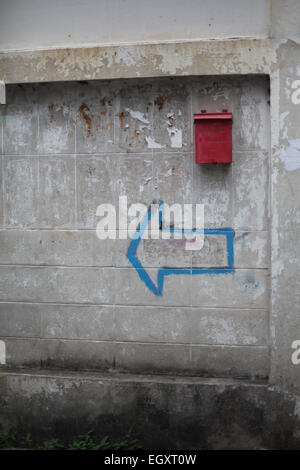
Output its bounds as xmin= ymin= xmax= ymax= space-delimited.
xmin=3 ymin=156 xmax=38 ymax=227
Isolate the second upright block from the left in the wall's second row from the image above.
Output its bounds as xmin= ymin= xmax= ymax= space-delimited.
xmin=39 ymin=155 xmax=76 ymax=228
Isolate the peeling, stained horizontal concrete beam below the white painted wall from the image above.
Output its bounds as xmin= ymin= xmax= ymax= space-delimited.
xmin=0 ymin=39 xmax=278 ymax=84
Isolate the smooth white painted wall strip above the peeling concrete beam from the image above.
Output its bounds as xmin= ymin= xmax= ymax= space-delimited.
xmin=0 ymin=0 xmax=271 ymax=51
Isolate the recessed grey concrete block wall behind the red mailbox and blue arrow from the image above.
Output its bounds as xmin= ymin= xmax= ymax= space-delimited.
xmin=0 ymin=76 xmax=270 ymax=379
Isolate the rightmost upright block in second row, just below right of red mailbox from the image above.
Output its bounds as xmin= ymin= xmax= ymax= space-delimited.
xmin=232 ymin=152 xmax=268 ymax=230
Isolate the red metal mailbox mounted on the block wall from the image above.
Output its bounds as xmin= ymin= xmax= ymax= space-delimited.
xmin=194 ymin=112 xmax=232 ymax=163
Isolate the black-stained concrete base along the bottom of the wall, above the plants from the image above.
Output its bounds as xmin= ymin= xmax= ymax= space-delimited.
xmin=0 ymin=370 xmax=300 ymax=449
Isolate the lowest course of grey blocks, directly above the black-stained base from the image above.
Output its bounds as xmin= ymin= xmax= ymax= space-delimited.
xmin=1 ymin=337 xmax=269 ymax=379
